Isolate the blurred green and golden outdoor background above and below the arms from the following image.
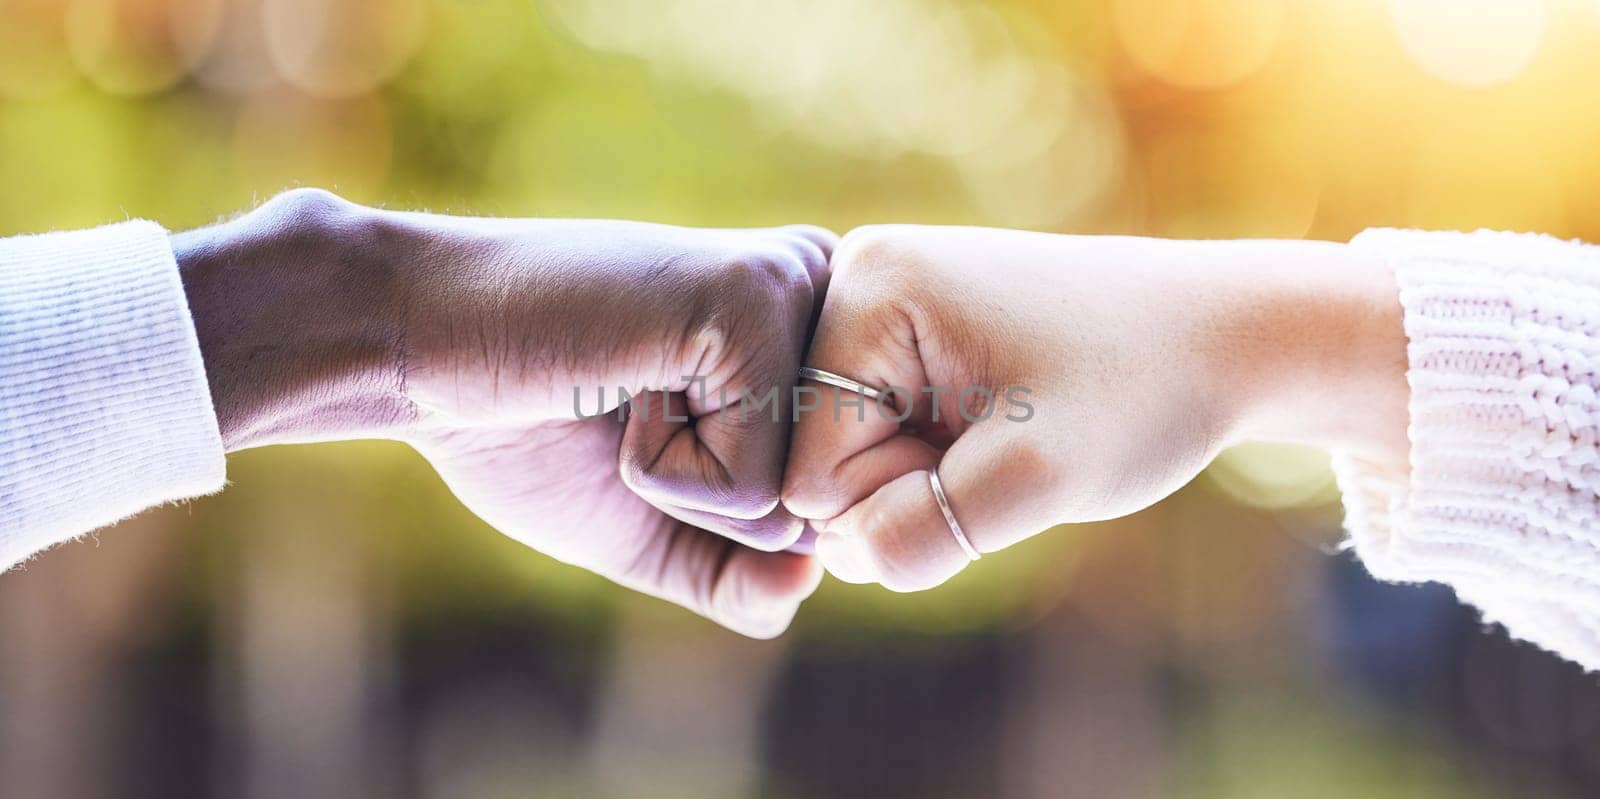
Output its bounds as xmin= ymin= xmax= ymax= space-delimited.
xmin=0 ymin=0 xmax=1600 ymax=799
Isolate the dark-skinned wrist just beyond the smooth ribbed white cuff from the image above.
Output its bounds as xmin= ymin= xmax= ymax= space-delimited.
xmin=171 ymin=191 xmax=411 ymax=452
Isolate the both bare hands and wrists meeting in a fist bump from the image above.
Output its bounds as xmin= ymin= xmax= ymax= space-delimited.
xmin=173 ymin=191 xmax=1408 ymax=636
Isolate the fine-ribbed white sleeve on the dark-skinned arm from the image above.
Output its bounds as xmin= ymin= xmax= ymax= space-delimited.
xmin=0 ymin=221 xmax=224 ymax=570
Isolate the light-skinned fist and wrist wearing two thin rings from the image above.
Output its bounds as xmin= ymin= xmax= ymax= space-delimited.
xmin=782 ymin=226 xmax=1408 ymax=591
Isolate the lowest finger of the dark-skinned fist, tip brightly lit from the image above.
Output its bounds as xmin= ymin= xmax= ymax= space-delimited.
xmin=619 ymin=524 xmax=822 ymax=639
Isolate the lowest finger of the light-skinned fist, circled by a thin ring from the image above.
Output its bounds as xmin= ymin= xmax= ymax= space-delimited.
xmin=818 ymin=424 xmax=1059 ymax=591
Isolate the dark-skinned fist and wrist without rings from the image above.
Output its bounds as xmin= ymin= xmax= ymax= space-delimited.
xmin=173 ymin=191 xmax=834 ymax=637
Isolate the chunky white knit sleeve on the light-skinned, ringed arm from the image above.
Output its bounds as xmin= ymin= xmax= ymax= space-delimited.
xmin=1334 ymin=231 xmax=1600 ymax=671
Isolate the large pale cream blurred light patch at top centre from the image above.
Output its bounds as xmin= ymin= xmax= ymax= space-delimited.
xmin=547 ymin=0 xmax=1120 ymax=227
